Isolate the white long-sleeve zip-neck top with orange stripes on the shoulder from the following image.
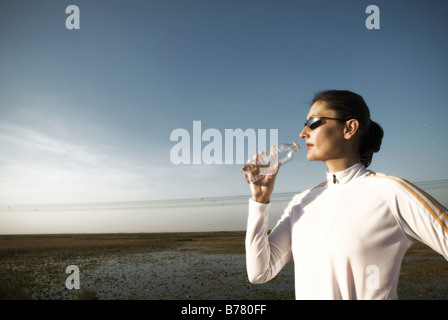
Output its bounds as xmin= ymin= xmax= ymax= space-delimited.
xmin=246 ymin=164 xmax=448 ymax=299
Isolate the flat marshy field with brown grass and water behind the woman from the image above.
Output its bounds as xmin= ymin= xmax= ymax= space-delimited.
xmin=0 ymin=231 xmax=448 ymax=300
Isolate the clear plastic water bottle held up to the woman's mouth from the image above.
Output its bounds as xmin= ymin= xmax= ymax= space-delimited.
xmin=241 ymin=142 xmax=300 ymax=183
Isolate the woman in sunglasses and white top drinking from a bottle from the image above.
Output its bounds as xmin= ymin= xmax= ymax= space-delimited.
xmin=246 ymin=90 xmax=448 ymax=299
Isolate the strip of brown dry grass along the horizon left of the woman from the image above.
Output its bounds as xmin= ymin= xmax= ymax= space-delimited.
xmin=0 ymin=232 xmax=244 ymax=260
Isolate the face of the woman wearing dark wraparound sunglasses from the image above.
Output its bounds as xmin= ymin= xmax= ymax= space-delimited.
xmin=300 ymin=101 xmax=347 ymax=162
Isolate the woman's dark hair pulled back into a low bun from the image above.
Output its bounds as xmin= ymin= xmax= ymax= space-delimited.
xmin=312 ymin=90 xmax=384 ymax=167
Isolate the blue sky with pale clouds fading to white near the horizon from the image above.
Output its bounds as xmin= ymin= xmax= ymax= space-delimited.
xmin=0 ymin=0 xmax=448 ymax=234
